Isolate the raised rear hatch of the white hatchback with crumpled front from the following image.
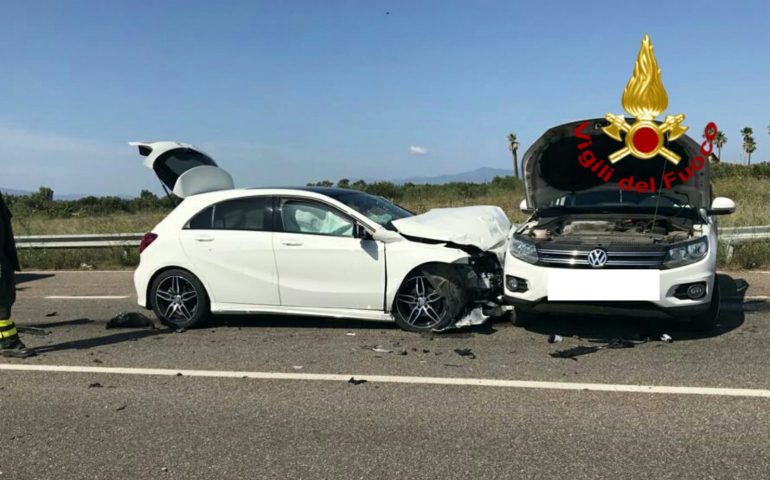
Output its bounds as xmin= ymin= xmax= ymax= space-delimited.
xmin=129 ymin=142 xmax=234 ymax=198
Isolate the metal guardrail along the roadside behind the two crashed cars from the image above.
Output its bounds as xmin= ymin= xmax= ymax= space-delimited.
xmin=16 ymin=225 xmax=770 ymax=253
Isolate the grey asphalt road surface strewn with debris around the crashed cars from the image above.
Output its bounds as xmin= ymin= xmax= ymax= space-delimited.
xmin=0 ymin=272 xmax=770 ymax=479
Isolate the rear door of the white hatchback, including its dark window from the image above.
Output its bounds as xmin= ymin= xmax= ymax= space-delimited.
xmin=180 ymin=196 xmax=280 ymax=305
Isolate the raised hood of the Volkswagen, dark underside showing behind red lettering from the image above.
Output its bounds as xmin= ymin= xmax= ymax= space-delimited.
xmin=522 ymin=118 xmax=711 ymax=209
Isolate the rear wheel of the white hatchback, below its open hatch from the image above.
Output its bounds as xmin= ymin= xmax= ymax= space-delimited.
xmin=150 ymin=269 xmax=209 ymax=328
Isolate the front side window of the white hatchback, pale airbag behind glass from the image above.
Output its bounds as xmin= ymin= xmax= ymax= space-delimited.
xmin=281 ymin=200 xmax=355 ymax=237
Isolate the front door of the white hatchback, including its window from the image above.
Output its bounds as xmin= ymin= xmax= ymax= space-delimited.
xmin=274 ymin=197 xmax=385 ymax=310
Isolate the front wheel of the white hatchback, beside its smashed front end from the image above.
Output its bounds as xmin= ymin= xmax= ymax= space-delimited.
xmin=393 ymin=264 xmax=468 ymax=332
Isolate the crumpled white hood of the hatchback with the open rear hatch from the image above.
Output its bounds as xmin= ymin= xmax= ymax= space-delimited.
xmin=393 ymin=206 xmax=511 ymax=253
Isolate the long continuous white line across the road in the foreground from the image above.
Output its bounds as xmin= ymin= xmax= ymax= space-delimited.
xmin=0 ymin=363 xmax=770 ymax=398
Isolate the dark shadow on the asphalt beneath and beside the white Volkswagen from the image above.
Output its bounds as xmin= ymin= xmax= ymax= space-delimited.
xmin=526 ymin=274 xmax=749 ymax=343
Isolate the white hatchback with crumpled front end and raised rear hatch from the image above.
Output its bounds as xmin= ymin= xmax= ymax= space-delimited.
xmin=131 ymin=142 xmax=510 ymax=331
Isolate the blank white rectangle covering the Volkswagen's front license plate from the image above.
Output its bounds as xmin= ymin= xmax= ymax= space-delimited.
xmin=548 ymin=269 xmax=660 ymax=301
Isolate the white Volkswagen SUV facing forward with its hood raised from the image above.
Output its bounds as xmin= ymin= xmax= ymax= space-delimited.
xmin=505 ymin=119 xmax=735 ymax=330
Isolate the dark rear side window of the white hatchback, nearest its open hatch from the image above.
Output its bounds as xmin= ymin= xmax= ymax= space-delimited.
xmin=187 ymin=197 xmax=273 ymax=232
